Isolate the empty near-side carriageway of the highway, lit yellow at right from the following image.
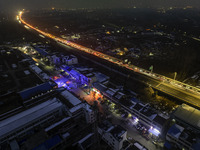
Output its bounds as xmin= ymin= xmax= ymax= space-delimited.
xmin=59 ymin=43 xmax=200 ymax=107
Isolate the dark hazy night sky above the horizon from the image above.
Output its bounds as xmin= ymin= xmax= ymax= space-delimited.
xmin=0 ymin=0 xmax=200 ymax=10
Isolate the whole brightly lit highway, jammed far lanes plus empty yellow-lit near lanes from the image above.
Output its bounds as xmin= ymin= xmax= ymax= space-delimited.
xmin=18 ymin=12 xmax=200 ymax=107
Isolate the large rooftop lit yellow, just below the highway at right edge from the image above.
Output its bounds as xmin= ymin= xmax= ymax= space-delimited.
xmin=173 ymin=104 xmax=200 ymax=130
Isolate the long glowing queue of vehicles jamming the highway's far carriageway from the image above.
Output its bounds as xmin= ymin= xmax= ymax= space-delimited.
xmin=17 ymin=11 xmax=200 ymax=94
